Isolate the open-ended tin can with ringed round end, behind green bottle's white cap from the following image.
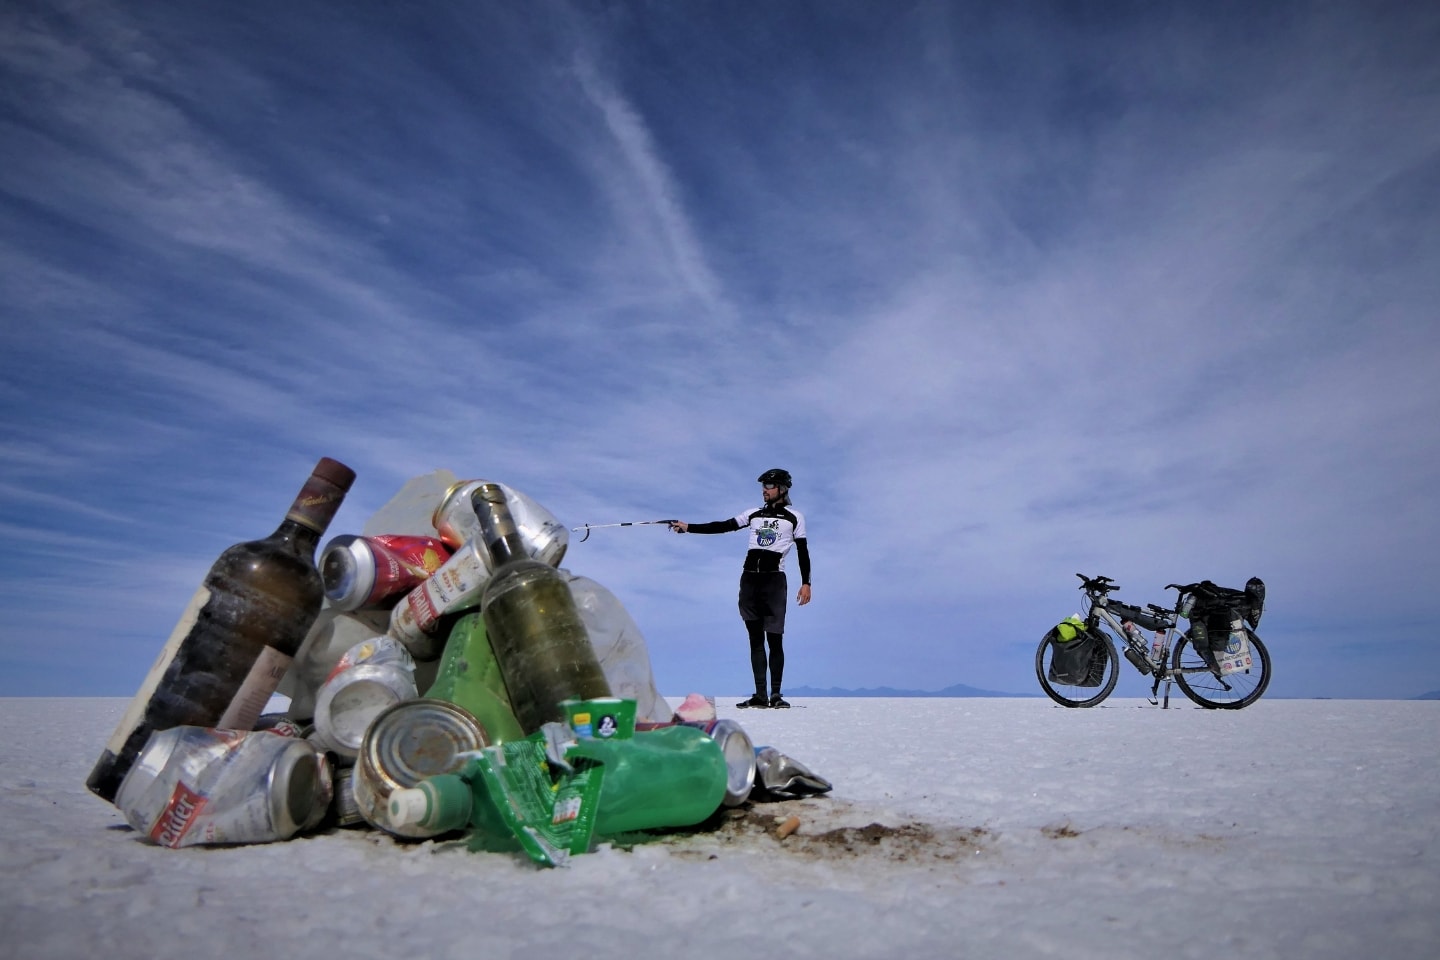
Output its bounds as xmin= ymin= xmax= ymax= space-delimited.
xmin=350 ymin=698 xmax=490 ymax=839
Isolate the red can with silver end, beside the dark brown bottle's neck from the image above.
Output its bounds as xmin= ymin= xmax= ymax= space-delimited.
xmin=317 ymin=534 xmax=451 ymax=610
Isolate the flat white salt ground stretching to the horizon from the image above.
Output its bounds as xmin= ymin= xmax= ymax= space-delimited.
xmin=0 ymin=698 xmax=1440 ymax=960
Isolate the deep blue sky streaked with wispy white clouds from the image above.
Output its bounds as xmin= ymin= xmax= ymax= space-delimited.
xmin=0 ymin=0 xmax=1440 ymax=697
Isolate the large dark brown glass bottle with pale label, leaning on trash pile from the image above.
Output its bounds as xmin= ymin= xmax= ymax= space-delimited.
xmin=85 ymin=456 xmax=356 ymax=803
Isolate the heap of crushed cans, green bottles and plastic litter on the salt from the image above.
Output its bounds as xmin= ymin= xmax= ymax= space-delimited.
xmin=89 ymin=461 xmax=831 ymax=866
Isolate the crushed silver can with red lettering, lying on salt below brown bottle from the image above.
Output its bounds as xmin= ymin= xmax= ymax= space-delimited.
xmin=115 ymin=727 xmax=333 ymax=848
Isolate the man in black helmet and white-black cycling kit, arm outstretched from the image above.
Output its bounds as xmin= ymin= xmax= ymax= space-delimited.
xmin=670 ymin=469 xmax=809 ymax=707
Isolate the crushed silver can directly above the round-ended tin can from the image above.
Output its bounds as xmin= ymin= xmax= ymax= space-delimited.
xmin=312 ymin=636 xmax=420 ymax=760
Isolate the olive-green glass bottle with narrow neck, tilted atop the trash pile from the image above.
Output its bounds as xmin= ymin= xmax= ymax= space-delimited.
xmin=472 ymin=484 xmax=611 ymax=735
